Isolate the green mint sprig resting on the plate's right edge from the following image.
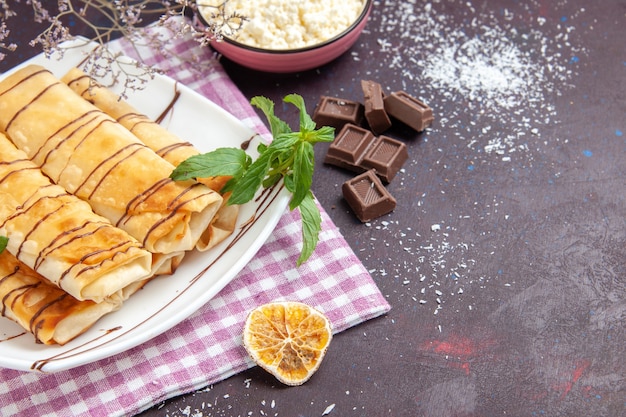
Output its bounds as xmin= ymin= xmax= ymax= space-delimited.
xmin=170 ymin=94 xmax=335 ymax=266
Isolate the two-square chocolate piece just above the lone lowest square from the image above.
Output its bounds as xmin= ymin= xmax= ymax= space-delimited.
xmin=324 ymin=124 xmax=409 ymax=183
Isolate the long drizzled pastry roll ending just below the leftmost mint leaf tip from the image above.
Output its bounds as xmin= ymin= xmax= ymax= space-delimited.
xmin=0 ymin=65 xmax=223 ymax=253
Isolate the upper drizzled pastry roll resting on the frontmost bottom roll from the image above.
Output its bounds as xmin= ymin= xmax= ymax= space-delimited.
xmin=0 ymin=134 xmax=153 ymax=302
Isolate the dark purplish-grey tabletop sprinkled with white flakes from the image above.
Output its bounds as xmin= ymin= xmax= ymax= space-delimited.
xmin=1 ymin=0 xmax=626 ymax=417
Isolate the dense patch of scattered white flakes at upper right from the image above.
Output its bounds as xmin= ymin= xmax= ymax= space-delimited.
xmin=374 ymin=0 xmax=584 ymax=162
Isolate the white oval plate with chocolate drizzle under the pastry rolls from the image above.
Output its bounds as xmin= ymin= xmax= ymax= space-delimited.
xmin=0 ymin=41 xmax=289 ymax=372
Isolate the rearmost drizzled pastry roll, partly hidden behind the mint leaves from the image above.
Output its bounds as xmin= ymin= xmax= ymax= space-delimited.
xmin=61 ymin=68 xmax=239 ymax=251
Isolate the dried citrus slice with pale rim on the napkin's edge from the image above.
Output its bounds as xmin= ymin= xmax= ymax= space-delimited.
xmin=243 ymin=301 xmax=332 ymax=385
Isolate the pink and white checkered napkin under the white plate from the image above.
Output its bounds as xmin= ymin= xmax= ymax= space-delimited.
xmin=0 ymin=31 xmax=390 ymax=416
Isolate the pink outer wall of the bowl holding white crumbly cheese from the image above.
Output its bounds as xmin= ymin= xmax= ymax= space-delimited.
xmin=199 ymin=0 xmax=373 ymax=73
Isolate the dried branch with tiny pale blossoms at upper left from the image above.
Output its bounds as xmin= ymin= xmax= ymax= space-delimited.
xmin=0 ymin=0 xmax=247 ymax=94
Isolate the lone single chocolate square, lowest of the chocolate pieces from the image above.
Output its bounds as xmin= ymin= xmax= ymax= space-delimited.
xmin=341 ymin=170 xmax=396 ymax=222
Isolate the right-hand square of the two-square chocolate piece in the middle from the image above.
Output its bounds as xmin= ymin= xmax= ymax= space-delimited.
xmin=361 ymin=136 xmax=409 ymax=183
